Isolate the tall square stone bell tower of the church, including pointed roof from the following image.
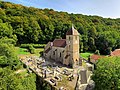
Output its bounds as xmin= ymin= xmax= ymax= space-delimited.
xmin=66 ymin=25 xmax=79 ymax=68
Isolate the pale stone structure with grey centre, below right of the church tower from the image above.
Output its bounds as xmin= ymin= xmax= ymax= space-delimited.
xmin=75 ymin=63 xmax=95 ymax=90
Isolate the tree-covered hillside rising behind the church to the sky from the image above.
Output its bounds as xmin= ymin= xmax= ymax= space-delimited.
xmin=0 ymin=2 xmax=120 ymax=54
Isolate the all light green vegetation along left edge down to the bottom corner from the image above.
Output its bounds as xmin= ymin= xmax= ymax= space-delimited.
xmin=0 ymin=37 xmax=36 ymax=90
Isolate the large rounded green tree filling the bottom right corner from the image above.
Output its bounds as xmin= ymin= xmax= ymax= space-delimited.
xmin=92 ymin=57 xmax=120 ymax=90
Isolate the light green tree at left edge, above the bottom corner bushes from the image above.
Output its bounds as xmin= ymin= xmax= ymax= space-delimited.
xmin=0 ymin=39 xmax=20 ymax=67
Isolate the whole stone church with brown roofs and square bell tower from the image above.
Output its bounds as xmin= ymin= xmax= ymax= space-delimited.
xmin=43 ymin=25 xmax=79 ymax=68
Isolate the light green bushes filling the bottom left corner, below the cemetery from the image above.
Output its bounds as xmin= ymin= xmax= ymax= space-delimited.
xmin=0 ymin=67 xmax=36 ymax=90
